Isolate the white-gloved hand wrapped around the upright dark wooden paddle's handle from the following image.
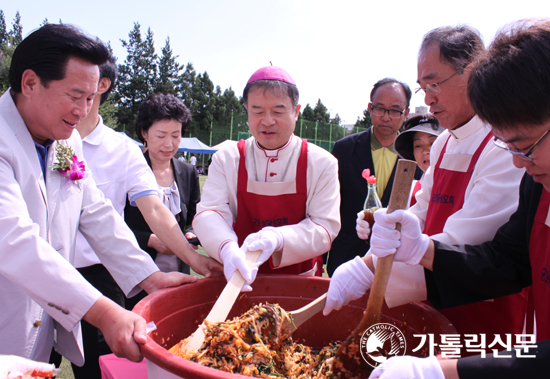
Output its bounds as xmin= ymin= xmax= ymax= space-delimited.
xmin=370 ymin=208 xmax=430 ymax=265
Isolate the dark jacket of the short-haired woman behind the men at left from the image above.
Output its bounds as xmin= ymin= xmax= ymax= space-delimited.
xmin=124 ymin=152 xmax=201 ymax=266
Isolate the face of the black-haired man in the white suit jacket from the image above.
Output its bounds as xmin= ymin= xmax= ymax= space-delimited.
xmin=22 ymin=58 xmax=99 ymax=144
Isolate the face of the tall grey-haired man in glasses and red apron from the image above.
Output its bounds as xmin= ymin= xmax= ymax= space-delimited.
xmin=417 ymin=44 xmax=475 ymax=129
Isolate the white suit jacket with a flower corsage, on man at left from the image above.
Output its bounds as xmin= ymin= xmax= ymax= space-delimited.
xmin=0 ymin=90 xmax=158 ymax=364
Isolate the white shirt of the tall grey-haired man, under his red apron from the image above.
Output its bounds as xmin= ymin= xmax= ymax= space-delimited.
xmin=373 ymin=116 xmax=525 ymax=307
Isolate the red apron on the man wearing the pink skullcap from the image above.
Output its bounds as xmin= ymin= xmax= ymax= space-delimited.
xmin=234 ymin=139 xmax=323 ymax=276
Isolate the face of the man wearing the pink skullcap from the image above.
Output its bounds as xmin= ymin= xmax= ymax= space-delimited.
xmin=246 ymin=87 xmax=300 ymax=150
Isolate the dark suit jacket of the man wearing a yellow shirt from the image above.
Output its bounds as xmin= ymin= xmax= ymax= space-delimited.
xmin=327 ymin=128 xmax=422 ymax=276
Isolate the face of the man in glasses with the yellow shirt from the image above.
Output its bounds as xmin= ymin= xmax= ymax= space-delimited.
xmin=368 ymin=83 xmax=409 ymax=142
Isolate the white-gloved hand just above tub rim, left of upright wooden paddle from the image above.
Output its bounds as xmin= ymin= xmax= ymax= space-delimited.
xmin=323 ymin=257 xmax=374 ymax=316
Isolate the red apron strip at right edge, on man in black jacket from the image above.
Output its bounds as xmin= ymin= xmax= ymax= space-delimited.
xmin=528 ymin=189 xmax=550 ymax=341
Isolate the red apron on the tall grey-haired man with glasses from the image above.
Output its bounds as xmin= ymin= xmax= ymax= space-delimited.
xmin=424 ymin=132 xmax=526 ymax=356
